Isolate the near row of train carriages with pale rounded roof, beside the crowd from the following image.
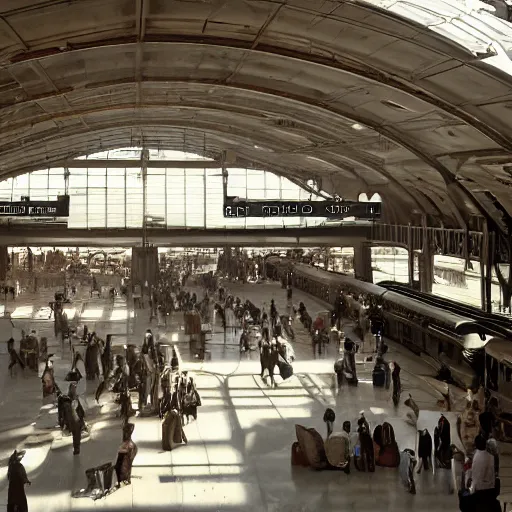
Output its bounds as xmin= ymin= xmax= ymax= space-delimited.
xmin=271 ymin=257 xmax=486 ymax=387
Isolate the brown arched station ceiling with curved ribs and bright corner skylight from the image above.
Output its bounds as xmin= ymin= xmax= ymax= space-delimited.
xmin=0 ymin=0 xmax=512 ymax=226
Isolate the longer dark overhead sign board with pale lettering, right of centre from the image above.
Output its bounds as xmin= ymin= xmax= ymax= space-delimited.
xmin=224 ymin=198 xmax=382 ymax=219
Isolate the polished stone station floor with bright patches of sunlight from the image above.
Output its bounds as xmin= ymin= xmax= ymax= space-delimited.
xmin=0 ymin=283 xmax=466 ymax=512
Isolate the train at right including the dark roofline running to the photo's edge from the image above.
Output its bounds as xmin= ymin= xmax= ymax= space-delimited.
xmin=265 ymin=255 xmax=512 ymax=389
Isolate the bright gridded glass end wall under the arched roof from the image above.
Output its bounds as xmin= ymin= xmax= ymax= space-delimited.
xmin=0 ymin=148 xmax=325 ymax=228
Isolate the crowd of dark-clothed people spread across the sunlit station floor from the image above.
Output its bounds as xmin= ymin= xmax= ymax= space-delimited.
xmin=4 ymin=259 xmax=506 ymax=512
